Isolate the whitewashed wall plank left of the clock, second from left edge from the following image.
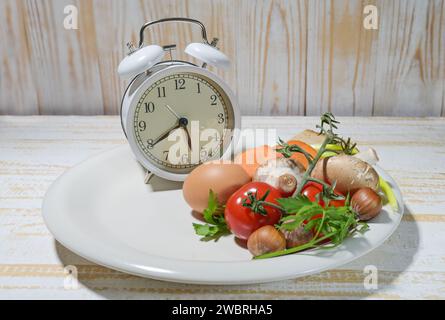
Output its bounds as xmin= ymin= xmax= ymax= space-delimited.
xmin=25 ymin=0 xmax=103 ymax=115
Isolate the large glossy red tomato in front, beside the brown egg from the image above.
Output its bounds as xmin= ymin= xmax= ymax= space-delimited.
xmin=224 ymin=182 xmax=281 ymax=240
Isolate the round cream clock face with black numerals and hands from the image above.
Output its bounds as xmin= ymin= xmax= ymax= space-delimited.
xmin=133 ymin=72 xmax=235 ymax=174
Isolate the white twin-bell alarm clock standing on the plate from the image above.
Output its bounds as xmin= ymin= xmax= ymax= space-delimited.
xmin=118 ymin=18 xmax=240 ymax=182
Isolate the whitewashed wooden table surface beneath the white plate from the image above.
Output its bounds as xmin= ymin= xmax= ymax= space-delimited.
xmin=0 ymin=116 xmax=445 ymax=299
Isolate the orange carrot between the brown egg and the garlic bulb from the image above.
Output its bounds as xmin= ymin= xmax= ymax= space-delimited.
xmin=234 ymin=145 xmax=282 ymax=177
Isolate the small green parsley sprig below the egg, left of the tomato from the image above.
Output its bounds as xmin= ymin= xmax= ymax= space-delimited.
xmin=193 ymin=190 xmax=230 ymax=241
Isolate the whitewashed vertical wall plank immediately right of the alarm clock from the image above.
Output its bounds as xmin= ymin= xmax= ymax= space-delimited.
xmin=235 ymin=1 xmax=307 ymax=115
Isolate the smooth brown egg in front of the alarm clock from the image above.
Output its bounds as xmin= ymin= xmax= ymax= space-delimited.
xmin=182 ymin=162 xmax=251 ymax=212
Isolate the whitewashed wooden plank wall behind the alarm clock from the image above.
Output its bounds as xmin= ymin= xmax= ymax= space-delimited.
xmin=0 ymin=0 xmax=445 ymax=116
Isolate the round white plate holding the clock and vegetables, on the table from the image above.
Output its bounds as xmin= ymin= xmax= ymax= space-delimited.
xmin=42 ymin=146 xmax=403 ymax=284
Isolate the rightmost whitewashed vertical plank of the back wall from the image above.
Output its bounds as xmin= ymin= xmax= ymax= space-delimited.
xmin=373 ymin=0 xmax=445 ymax=116
